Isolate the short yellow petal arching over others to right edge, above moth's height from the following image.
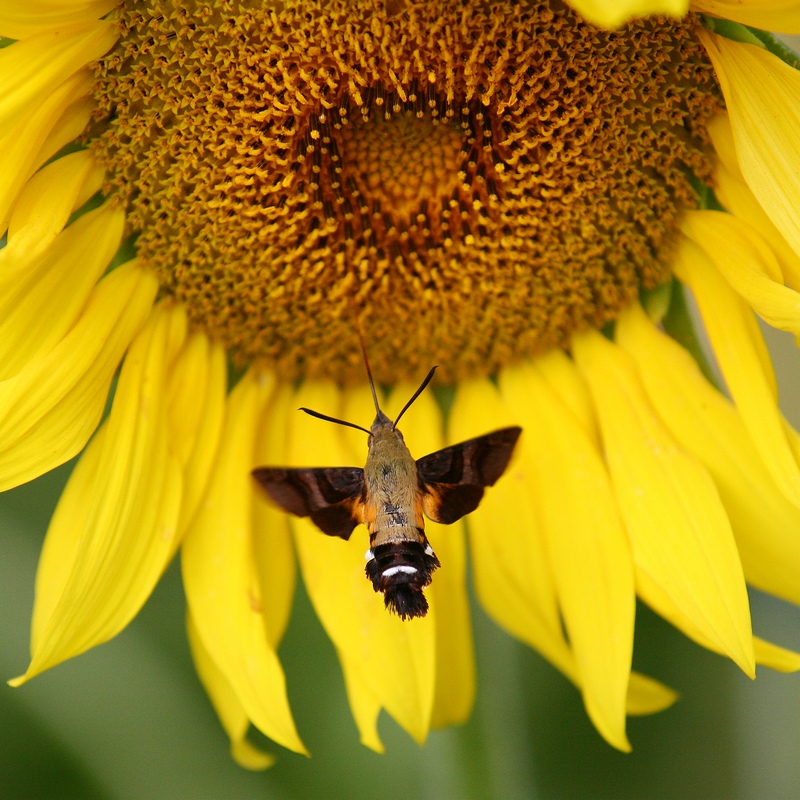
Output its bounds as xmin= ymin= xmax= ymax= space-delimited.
xmin=681 ymin=211 xmax=800 ymax=336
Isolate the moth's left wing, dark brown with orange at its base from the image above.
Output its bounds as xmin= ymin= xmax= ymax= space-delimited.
xmin=253 ymin=467 xmax=366 ymax=539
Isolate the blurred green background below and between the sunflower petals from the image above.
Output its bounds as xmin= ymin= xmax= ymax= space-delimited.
xmin=0 ymin=318 xmax=800 ymax=800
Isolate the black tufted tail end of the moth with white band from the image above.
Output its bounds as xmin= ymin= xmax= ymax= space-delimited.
xmin=366 ymin=534 xmax=440 ymax=619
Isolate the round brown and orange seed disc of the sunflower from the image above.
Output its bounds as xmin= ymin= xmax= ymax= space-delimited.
xmin=89 ymin=0 xmax=721 ymax=382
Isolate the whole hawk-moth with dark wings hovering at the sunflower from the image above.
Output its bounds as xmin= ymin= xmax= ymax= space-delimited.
xmin=253 ymin=366 xmax=522 ymax=620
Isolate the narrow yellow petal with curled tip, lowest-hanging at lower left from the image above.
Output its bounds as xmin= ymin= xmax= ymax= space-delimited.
xmin=186 ymin=614 xmax=275 ymax=770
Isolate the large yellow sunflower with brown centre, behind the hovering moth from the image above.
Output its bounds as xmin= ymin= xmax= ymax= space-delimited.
xmin=0 ymin=0 xmax=800 ymax=768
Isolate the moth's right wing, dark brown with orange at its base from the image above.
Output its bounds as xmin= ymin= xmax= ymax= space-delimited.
xmin=417 ymin=427 xmax=522 ymax=525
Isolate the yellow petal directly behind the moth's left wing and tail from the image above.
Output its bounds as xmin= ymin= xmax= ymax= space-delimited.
xmin=288 ymin=381 xmax=436 ymax=742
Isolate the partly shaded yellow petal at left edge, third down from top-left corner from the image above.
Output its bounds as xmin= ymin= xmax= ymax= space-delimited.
xmin=0 ymin=71 xmax=92 ymax=231
